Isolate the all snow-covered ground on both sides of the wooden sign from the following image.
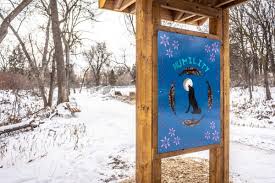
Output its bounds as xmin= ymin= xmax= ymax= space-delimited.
xmin=0 ymin=87 xmax=275 ymax=183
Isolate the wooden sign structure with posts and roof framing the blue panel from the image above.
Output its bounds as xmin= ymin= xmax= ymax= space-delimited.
xmin=99 ymin=0 xmax=246 ymax=183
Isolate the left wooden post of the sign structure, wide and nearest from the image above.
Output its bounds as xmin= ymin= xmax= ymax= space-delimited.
xmin=136 ymin=0 xmax=161 ymax=183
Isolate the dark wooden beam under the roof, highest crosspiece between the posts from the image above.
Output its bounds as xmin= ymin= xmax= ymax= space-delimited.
xmin=160 ymin=0 xmax=221 ymax=17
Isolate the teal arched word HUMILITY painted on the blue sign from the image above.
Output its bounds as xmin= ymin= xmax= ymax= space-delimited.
xmin=173 ymin=57 xmax=210 ymax=72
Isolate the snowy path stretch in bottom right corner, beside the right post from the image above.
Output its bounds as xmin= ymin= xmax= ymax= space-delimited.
xmin=230 ymin=143 xmax=275 ymax=183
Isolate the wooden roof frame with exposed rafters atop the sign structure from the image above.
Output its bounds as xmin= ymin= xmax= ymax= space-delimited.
xmin=99 ymin=0 xmax=247 ymax=26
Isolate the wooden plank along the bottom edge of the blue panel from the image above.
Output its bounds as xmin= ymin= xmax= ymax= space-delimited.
xmin=157 ymin=144 xmax=220 ymax=158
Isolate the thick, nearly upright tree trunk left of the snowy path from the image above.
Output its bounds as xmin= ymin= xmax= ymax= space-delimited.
xmin=50 ymin=0 xmax=69 ymax=104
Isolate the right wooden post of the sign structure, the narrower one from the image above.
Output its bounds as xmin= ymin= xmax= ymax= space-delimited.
xmin=209 ymin=9 xmax=230 ymax=183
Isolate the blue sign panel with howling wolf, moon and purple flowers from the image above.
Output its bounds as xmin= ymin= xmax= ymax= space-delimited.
xmin=158 ymin=31 xmax=221 ymax=153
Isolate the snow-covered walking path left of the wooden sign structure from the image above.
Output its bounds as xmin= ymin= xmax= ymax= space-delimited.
xmin=0 ymin=93 xmax=135 ymax=183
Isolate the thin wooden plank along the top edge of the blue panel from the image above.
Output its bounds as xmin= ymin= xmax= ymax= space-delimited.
xmin=158 ymin=26 xmax=221 ymax=40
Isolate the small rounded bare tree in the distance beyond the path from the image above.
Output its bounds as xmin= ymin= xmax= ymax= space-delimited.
xmin=84 ymin=42 xmax=112 ymax=86
